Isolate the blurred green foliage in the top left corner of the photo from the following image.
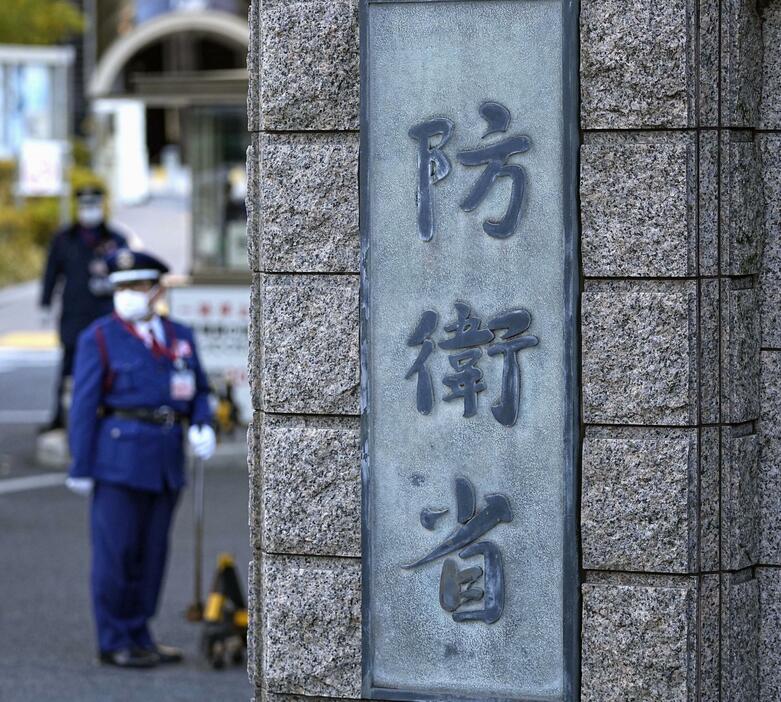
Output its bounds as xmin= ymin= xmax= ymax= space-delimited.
xmin=0 ymin=0 xmax=84 ymax=44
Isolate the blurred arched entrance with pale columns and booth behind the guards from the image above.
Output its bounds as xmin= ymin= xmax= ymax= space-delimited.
xmin=88 ymin=10 xmax=249 ymax=275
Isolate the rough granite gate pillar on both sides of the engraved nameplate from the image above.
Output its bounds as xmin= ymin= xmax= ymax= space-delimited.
xmin=248 ymin=0 xmax=781 ymax=702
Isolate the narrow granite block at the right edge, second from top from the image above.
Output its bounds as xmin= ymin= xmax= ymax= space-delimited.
xmin=759 ymin=133 xmax=781 ymax=348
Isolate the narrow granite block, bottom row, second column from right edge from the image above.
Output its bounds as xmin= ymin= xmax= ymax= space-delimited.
xmin=721 ymin=571 xmax=759 ymax=702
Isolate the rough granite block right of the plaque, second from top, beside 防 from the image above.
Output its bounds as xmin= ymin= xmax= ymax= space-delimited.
xmin=580 ymin=133 xmax=697 ymax=277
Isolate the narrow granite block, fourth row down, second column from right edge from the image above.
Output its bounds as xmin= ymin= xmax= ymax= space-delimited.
xmin=721 ymin=425 xmax=760 ymax=570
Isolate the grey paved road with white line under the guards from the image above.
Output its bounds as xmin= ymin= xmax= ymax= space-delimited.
xmin=0 ymin=349 xmax=251 ymax=702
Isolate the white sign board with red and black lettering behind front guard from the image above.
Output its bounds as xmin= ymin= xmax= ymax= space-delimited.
xmin=168 ymin=285 xmax=252 ymax=423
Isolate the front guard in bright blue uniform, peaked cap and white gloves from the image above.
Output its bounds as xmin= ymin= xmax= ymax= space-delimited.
xmin=67 ymin=249 xmax=216 ymax=668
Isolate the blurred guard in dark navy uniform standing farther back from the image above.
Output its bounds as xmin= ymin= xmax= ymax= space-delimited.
xmin=40 ymin=187 xmax=127 ymax=431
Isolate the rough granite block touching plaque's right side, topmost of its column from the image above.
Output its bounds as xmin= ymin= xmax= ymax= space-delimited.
xmin=580 ymin=0 xmax=695 ymax=129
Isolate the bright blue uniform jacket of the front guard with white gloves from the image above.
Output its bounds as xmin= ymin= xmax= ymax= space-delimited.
xmin=69 ymin=314 xmax=211 ymax=492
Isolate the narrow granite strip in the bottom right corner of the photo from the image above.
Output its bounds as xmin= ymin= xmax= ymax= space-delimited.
xmin=757 ymin=568 xmax=781 ymax=702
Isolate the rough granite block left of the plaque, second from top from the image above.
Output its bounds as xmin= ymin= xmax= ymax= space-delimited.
xmin=259 ymin=134 xmax=359 ymax=273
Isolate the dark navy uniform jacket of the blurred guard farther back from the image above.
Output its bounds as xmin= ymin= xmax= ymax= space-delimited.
xmin=41 ymin=223 xmax=127 ymax=346
